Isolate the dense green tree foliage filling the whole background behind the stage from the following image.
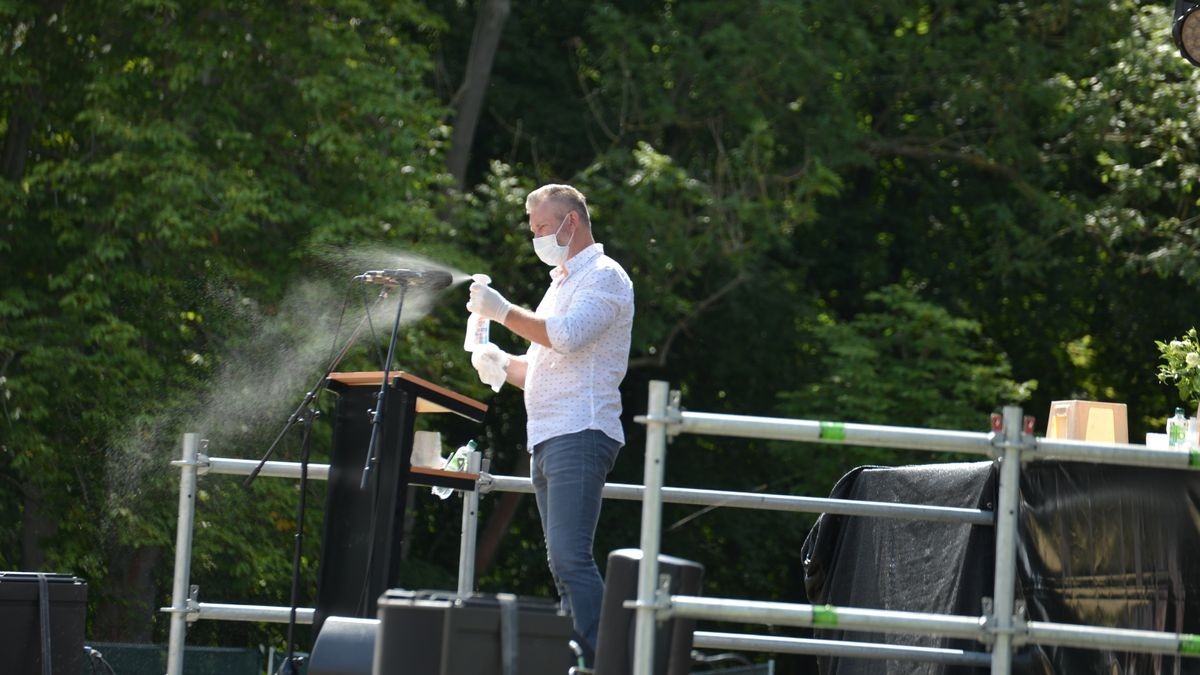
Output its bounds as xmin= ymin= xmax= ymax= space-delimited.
xmin=0 ymin=0 xmax=1200 ymax=662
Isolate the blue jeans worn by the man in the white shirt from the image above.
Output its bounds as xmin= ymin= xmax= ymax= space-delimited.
xmin=529 ymin=429 xmax=620 ymax=663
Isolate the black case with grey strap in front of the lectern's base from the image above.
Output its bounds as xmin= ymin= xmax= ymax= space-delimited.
xmin=373 ymin=590 xmax=572 ymax=675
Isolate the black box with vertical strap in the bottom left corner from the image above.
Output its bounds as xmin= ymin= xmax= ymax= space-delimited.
xmin=0 ymin=572 xmax=88 ymax=675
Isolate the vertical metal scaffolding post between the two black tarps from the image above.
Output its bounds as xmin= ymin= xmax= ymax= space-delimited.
xmin=991 ymin=406 xmax=1025 ymax=675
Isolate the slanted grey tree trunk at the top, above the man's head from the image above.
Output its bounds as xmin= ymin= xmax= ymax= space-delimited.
xmin=446 ymin=0 xmax=512 ymax=190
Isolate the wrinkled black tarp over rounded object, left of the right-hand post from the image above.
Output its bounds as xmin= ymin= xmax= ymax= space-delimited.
xmin=803 ymin=461 xmax=996 ymax=675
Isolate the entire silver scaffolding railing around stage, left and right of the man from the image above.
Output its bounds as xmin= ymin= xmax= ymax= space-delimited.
xmin=163 ymin=383 xmax=1200 ymax=675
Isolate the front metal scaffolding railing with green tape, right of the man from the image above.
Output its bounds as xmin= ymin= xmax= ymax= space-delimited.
xmin=629 ymin=382 xmax=1200 ymax=675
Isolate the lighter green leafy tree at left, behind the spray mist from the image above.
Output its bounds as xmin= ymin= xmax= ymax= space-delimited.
xmin=0 ymin=1 xmax=451 ymax=637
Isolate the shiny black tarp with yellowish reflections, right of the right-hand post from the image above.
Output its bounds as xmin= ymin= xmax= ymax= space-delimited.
xmin=1016 ymin=462 xmax=1200 ymax=675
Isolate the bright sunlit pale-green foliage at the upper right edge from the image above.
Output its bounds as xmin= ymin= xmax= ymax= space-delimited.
xmin=1052 ymin=6 xmax=1200 ymax=283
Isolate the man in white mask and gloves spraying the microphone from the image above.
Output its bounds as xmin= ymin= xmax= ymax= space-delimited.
xmin=467 ymin=185 xmax=634 ymax=664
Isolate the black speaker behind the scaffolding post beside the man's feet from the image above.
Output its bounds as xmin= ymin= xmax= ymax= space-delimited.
xmin=595 ymin=549 xmax=704 ymax=675
